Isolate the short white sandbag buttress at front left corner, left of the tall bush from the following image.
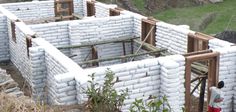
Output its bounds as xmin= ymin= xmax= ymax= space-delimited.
xmin=47 ymin=73 xmax=78 ymax=105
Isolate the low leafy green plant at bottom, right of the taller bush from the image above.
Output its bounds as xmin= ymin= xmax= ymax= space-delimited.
xmin=129 ymin=96 xmax=171 ymax=112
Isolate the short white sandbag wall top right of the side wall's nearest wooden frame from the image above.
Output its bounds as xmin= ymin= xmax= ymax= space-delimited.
xmin=209 ymin=38 xmax=234 ymax=49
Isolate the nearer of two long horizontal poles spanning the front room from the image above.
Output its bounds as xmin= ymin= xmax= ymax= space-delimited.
xmin=79 ymin=49 xmax=166 ymax=65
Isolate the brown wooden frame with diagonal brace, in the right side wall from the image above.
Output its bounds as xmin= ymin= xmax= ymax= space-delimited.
xmin=141 ymin=19 xmax=157 ymax=46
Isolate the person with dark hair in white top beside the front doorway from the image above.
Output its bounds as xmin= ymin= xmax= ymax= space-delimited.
xmin=208 ymin=81 xmax=224 ymax=112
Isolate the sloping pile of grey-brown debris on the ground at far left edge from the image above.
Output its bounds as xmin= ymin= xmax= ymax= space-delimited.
xmin=0 ymin=69 xmax=24 ymax=97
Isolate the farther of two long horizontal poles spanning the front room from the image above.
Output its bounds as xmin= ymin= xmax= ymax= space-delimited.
xmin=57 ymin=38 xmax=138 ymax=49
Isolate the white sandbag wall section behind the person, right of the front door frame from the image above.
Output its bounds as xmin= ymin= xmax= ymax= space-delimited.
xmin=213 ymin=47 xmax=236 ymax=112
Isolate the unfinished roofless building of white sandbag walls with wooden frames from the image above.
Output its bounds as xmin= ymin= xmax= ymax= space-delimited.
xmin=0 ymin=0 xmax=236 ymax=112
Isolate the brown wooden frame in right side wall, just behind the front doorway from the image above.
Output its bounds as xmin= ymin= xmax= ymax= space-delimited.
xmin=187 ymin=32 xmax=214 ymax=53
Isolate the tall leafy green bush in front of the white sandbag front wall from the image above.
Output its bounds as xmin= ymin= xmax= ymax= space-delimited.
xmin=86 ymin=69 xmax=128 ymax=112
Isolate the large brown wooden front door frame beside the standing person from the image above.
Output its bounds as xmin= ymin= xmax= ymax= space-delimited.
xmin=185 ymin=52 xmax=219 ymax=112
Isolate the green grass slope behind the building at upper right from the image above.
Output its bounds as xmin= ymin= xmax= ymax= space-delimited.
xmin=153 ymin=0 xmax=236 ymax=34
